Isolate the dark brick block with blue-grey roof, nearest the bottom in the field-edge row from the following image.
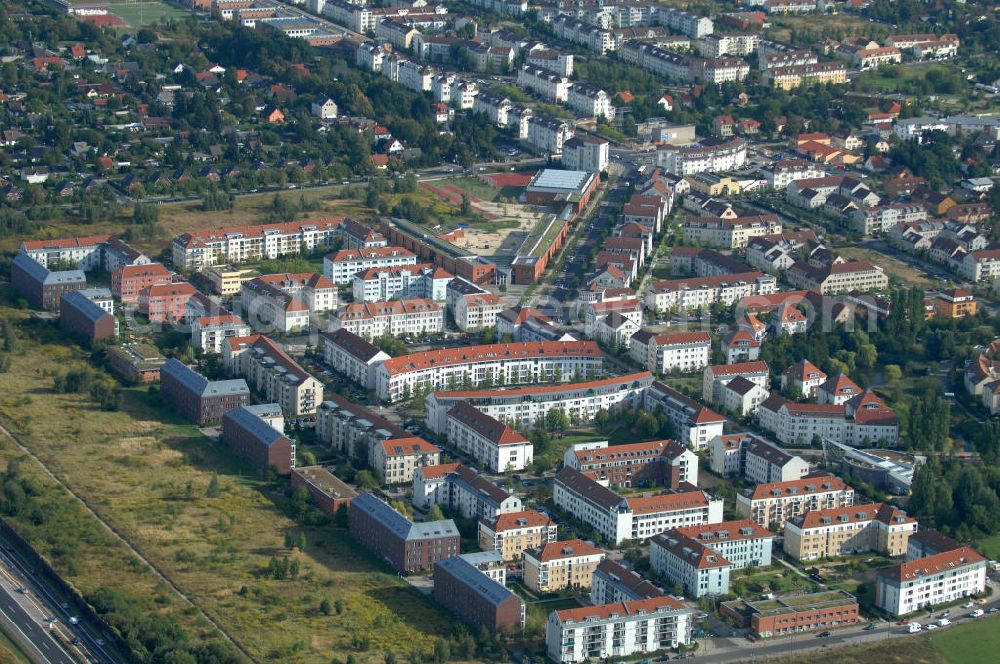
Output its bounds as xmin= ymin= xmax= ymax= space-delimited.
xmin=433 ymin=556 xmax=525 ymax=636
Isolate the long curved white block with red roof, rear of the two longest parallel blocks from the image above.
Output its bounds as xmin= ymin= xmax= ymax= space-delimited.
xmin=374 ymin=341 xmax=603 ymax=401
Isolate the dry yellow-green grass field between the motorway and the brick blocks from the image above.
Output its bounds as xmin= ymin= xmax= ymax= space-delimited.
xmin=0 ymin=309 xmax=449 ymax=663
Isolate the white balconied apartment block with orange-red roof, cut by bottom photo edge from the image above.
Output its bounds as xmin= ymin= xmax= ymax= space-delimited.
xmin=545 ymin=596 xmax=707 ymax=664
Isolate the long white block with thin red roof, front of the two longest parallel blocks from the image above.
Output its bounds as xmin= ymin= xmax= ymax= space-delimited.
xmin=427 ymin=372 xmax=653 ymax=434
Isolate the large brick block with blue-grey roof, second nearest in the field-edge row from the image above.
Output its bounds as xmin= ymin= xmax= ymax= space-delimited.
xmin=350 ymin=493 xmax=461 ymax=572
